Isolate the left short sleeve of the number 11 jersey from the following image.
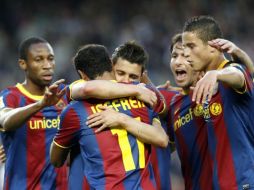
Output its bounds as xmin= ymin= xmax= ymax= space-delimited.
xmin=54 ymin=105 xmax=80 ymax=148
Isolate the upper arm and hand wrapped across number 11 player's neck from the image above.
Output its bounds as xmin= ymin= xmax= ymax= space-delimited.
xmin=70 ymin=80 xmax=157 ymax=107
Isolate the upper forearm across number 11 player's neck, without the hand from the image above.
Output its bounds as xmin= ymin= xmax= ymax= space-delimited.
xmin=71 ymin=80 xmax=139 ymax=99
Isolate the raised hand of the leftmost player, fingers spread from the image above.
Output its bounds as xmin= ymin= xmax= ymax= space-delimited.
xmin=39 ymin=79 xmax=66 ymax=107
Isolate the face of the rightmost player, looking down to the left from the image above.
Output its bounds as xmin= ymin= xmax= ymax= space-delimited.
xmin=182 ymin=32 xmax=211 ymax=71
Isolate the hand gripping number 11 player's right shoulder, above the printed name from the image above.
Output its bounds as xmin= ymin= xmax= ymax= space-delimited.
xmin=136 ymin=83 xmax=157 ymax=107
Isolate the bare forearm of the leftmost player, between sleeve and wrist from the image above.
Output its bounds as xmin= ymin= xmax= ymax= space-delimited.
xmin=0 ymin=102 xmax=43 ymax=131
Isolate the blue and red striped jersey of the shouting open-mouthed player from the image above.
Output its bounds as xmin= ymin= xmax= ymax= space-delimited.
xmin=168 ymin=93 xmax=213 ymax=190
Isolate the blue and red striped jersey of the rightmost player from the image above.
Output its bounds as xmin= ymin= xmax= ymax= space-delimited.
xmin=204 ymin=63 xmax=254 ymax=190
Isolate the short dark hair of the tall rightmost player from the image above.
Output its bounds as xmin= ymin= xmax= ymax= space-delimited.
xmin=183 ymin=15 xmax=223 ymax=43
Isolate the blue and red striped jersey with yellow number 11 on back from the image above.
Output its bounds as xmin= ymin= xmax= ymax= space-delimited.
xmin=54 ymin=94 xmax=163 ymax=189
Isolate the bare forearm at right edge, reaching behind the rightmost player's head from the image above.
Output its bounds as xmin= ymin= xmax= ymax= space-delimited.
xmin=232 ymin=48 xmax=254 ymax=74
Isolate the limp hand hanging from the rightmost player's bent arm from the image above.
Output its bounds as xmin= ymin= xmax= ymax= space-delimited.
xmin=192 ymin=71 xmax=218 ymax=104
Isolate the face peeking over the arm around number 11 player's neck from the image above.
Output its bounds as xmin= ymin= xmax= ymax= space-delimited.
xmin=113 ymin=58 xmax=142 ymax=83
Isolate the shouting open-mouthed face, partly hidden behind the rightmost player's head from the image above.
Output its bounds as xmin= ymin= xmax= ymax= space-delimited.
xmin=170 ymin=42 xmax=198 ymax=89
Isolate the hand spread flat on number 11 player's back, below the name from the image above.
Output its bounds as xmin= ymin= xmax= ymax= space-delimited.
xmin=86 ymin=106 xmax=124 ymax=133
